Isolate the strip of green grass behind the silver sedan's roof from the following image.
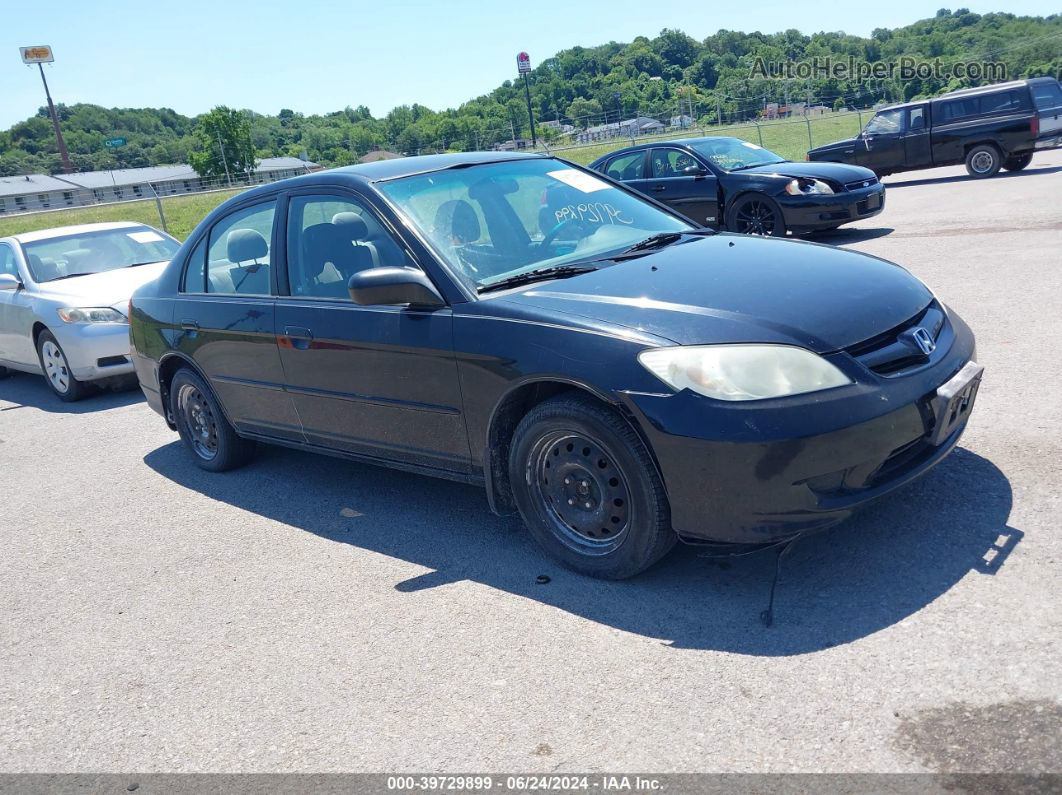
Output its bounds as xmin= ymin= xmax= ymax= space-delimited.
xmin=0 ymin=190 xmax=240 ymax=240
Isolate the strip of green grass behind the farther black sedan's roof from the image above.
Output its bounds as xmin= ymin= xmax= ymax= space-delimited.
xmin=553 ymin=111 xmax=872 ymax=166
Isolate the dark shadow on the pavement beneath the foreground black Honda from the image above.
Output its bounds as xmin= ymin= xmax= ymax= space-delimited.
xmin=144 ymin=442 xmax=1022 ymax=656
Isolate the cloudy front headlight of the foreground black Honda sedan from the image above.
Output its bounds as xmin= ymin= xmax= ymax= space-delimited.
xmin=638 ymin=345 xmax=852 ymax=400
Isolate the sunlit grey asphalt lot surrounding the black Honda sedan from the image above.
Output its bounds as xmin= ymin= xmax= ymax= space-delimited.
xmin=0 ymin=152 xmax=1062 ymax=772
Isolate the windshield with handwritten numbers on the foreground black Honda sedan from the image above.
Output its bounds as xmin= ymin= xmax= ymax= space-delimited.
xmin=380 ymin=157 xmax=693 ymax=289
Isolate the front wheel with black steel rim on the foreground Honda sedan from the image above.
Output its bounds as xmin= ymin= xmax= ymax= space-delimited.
xmin=509 ymin=394 xmax=676 ymax=580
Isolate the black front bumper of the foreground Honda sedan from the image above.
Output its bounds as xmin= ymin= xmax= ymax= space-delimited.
xmin=624 ymin=305 xmax=975 ymax=545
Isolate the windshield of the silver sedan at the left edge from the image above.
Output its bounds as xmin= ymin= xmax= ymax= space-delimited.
xmin=22 ymin=226 xmax=181 ymax=283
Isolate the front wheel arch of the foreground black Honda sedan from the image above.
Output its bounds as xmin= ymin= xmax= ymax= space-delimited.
xmin=483 ymin=376 xmax=663 ymax=516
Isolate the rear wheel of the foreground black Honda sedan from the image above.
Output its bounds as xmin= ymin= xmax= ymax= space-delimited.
xmin=169 ymin=367 xmax=255 ymax=472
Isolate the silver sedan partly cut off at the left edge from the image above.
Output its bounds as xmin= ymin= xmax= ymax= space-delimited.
xmin=0 ymin=222 xmax=181 ymax=401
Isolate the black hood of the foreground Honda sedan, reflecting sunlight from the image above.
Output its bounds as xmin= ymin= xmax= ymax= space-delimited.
xmin=499 ymin=234 xmax=932 ymax=353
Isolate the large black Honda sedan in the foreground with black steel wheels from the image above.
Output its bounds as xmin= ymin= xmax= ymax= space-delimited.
xmin=131 ymin=154 xmax=981 ymax=577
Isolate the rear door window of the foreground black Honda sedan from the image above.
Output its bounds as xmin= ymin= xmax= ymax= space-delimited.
xmin=206 ymin=200 xmax=276 ymax=295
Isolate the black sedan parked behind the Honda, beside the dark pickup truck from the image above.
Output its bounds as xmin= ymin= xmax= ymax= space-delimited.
xmin=590 ymin=137 xmax=885 ymax=237
